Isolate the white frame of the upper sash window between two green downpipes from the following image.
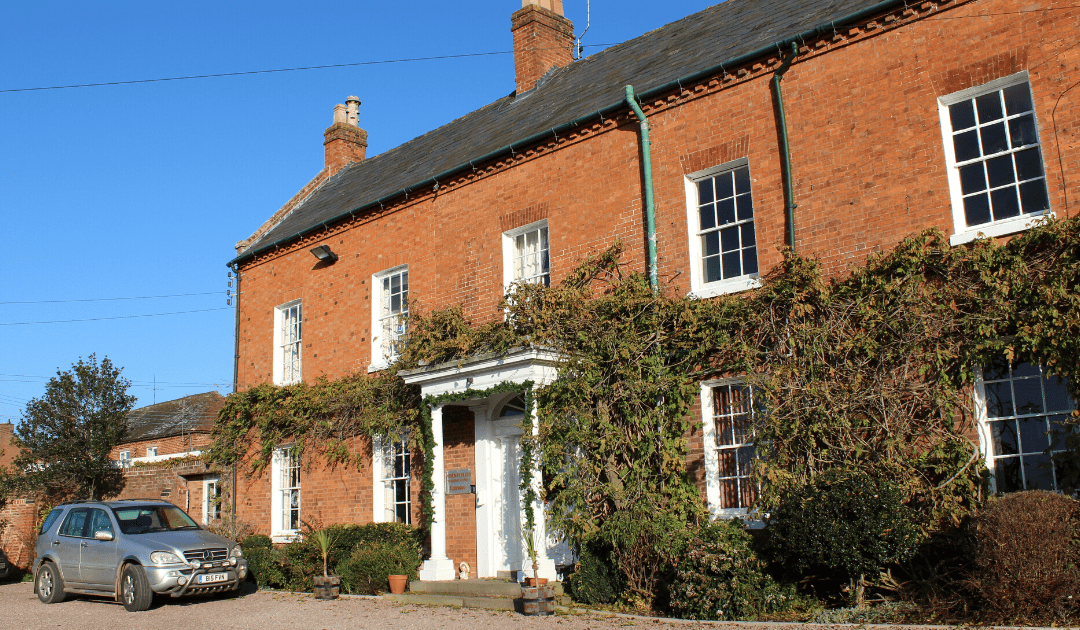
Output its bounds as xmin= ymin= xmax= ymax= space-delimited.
xmin=683 ymin=158 xmax=761 ymax=298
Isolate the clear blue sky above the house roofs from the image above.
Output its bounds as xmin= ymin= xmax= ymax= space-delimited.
xmin=0 ymin=0 xmax=716 ymax=423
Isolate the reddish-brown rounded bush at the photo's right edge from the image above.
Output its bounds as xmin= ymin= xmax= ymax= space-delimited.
xmin=973 ymin=491 xmax=1080 ymax=625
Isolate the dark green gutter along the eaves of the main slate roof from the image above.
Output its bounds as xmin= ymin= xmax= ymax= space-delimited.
xmin=227 ymin=0 xmax=907 ymax=266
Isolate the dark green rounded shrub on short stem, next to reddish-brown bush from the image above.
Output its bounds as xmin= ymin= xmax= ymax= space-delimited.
xmin=768 ymin=470 xmax=922 ymax=603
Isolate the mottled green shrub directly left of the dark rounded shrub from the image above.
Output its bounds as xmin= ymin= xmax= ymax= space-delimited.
xmin=671 ymin=520 xmax=798 ymax=620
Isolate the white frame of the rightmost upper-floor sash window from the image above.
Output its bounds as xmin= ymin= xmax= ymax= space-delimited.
xmin=937 ymin=70 xmax=1054 ymax=245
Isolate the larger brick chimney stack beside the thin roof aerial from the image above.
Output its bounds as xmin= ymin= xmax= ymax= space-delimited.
xmin=510 ymin=0 xmax=573 ymax=94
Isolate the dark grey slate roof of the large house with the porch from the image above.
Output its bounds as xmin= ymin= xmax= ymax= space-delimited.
xmin=234 ymin=0 xmax=903 ymax=262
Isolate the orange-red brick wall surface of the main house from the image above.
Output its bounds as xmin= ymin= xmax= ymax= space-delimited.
xmin=238 ymin=0 xmax=1080 ymax=554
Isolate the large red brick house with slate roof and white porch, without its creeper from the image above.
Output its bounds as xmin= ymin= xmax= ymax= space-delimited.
xmin=230 ymin=0 xmax=1080 ymax=579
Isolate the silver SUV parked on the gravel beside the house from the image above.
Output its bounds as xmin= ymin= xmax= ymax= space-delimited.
xmin=33 ymin=499 xmax=247 ymax=612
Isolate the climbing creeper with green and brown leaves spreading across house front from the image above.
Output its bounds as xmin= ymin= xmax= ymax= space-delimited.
xmin=211 ymin=219 xmax=1080 ymax=574
